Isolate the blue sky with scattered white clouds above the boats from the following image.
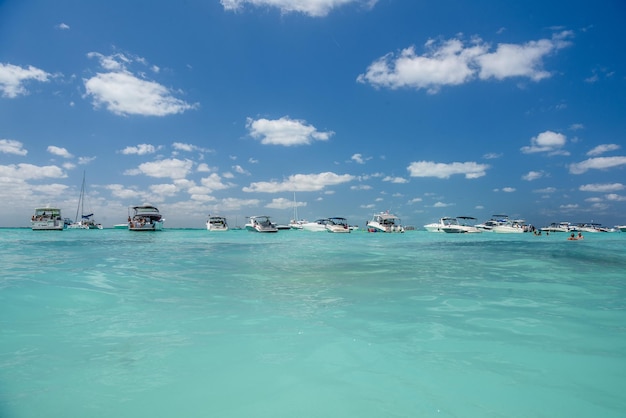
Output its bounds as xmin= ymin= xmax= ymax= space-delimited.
xmin=0 ymin=0 xmax=626 ymax=228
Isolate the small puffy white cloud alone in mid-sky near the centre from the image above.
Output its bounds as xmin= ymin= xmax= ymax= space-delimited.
xmin=246 ymin=116 xmax=335 ymax=146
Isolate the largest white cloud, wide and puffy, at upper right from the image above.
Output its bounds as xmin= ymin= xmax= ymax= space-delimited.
xmin=357 ymin=32 xmax=571 ymax=93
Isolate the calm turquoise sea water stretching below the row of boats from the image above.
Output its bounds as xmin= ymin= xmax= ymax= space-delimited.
xmin=0 ymin=229 xmax=626 ymax=418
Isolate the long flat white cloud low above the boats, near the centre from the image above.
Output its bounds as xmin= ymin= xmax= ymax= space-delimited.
xmin=243 ymin=172 xmax=355 ymax=193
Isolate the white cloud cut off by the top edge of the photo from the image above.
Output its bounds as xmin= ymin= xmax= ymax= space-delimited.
xmin=220 ymin=0 xmax=378 ymax=17
